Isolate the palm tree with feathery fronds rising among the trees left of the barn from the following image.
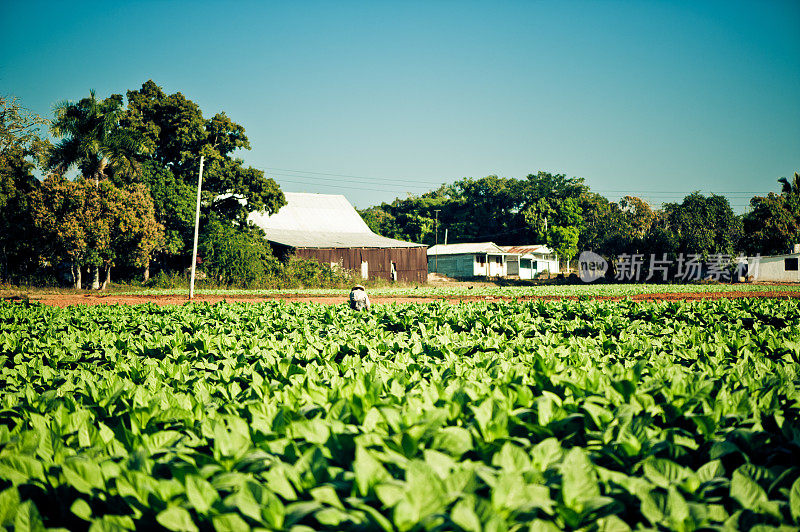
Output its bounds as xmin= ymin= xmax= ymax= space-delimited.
xmin=47 ymin=90 xmax=143 ymax=289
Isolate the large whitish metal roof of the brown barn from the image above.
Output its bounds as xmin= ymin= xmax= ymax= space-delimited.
xmin=247 ymin=192 xmax=423 ymax=248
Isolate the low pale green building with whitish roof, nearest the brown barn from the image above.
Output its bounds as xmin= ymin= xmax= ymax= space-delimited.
xmin=428 ymin=242 xmax=513 ymax=277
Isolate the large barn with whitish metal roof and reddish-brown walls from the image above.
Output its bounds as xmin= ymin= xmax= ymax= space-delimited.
xmin=248 ymin=192 xmax=428 ymax=283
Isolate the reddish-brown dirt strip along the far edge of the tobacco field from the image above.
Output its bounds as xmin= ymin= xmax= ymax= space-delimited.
xmin=6 ymin=290 xmax=800 ymax=307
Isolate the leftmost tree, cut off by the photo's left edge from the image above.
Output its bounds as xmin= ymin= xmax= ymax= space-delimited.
xmin=0 ymin=95 xmax=49 ymax=281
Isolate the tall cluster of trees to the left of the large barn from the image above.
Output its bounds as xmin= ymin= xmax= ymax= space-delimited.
xmin=0 ymin=80 xmax=300 ymax=288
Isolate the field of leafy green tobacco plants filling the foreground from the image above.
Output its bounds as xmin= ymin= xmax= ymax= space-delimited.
xmin=0 ymin=298 xmax=800 ymax=532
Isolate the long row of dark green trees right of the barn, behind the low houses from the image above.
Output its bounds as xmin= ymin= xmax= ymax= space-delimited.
xmin=360 ymin=172 xmax=800 ymax=270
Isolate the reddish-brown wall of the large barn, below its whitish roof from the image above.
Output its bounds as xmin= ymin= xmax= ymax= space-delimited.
xmin=295 ymin=247 xmax=428 ymax=283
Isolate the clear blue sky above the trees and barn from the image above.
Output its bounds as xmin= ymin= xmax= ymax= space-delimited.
xmin=0 ymin=0 xmax=800 ymax=212
